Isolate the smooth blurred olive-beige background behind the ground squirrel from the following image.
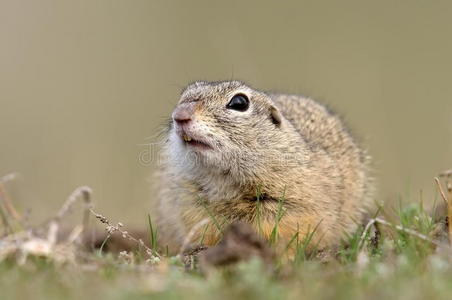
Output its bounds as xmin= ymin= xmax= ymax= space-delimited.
xmin=0 ymin=0 xmax=452 ymax=225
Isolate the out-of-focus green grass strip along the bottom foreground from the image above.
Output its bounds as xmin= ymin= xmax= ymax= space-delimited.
xmin=0 ymin=232 xmax=452 ymax=300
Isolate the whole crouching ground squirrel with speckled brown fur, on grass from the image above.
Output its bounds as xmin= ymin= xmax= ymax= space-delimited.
xmin=153 ymin=81 xmax=372 ymax=252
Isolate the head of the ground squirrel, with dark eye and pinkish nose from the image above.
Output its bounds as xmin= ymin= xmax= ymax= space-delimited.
xmin=168 ymin=81 xmax=300 ymax=182
